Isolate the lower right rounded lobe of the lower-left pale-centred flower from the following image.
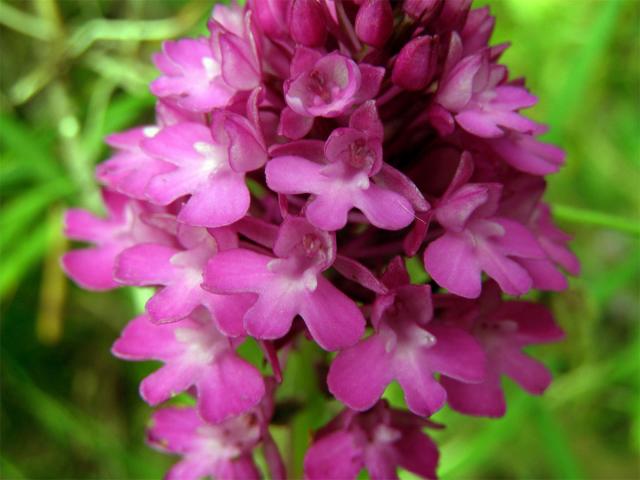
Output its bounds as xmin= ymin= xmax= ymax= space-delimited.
xmin=196 ymin=352 xmax=265 ymax=423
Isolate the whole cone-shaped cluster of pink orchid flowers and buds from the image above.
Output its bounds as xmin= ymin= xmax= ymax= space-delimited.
xmin=63 ymin=0 xmax=579 ymax=479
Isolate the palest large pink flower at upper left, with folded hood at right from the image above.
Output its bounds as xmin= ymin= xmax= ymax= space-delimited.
xmin=142 ymin=112 xmax=267 ymax=227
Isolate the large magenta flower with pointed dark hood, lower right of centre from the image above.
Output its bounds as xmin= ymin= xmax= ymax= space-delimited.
xmin=328 ymin=258 xmax=485 ymax=415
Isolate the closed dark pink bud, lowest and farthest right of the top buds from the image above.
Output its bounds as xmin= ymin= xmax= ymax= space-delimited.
xmin=391 ymin=35 xmax=437 ymax=90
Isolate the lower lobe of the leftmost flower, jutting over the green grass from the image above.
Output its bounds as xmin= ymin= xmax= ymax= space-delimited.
xmin=62 ymin=246 xmax=120 ymax=290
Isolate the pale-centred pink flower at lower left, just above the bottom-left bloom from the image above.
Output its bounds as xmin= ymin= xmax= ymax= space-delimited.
xmin=112 ymin=310 xmax=265 ymax=423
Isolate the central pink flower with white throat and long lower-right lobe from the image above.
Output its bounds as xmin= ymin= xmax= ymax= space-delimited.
xmin=204 ymin=217 xmax=364 ymax=350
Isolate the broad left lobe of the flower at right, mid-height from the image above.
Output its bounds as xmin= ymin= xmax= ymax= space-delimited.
xmin=424 ymin=233 xmax=482 ymax=298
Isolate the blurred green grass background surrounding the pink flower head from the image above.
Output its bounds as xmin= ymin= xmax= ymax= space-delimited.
xmin=0 ymin=0 xmax=640 ymax=479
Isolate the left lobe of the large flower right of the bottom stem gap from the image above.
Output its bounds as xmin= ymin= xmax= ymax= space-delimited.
xmin=327 ymin=334 xmax=393 ymax=410
